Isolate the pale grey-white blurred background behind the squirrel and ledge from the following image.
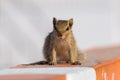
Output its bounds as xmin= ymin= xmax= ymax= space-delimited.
xmin=0 ymin=0 xmax=120 ymax=69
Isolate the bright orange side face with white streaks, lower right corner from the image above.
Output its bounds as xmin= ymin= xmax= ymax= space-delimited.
xmin=93 ymin=58 xmax=120 ymax=80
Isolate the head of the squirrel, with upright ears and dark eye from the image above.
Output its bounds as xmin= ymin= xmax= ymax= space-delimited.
xmin=53 ymin=17 xmax=73 ymax=36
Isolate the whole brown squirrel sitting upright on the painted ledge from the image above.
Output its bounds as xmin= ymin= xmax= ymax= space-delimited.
xmin=31 ymin=18 xmax=86 ymax=65
